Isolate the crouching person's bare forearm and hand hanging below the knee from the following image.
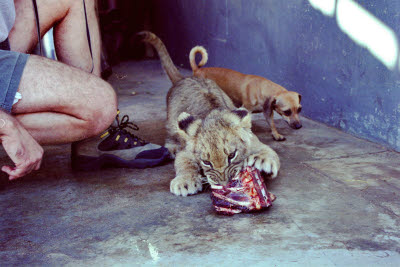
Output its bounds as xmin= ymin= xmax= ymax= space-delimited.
xmin=0 ymin=110 xmax=43 ymax=180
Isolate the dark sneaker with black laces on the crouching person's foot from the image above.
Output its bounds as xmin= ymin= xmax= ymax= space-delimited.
xmin=71 ymin=111 xmax=169 ymax=171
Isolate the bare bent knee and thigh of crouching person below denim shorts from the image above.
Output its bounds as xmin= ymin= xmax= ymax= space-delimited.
xmin=12 ymin=56 xmax=117 ymax=144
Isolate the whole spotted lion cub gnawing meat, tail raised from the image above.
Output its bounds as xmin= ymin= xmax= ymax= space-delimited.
xmin=139 ymin=32 xmax=280 ymax=196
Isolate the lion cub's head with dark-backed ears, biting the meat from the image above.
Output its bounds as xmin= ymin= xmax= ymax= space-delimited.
xmin=179 ymin=109 xmax=252 ymax=185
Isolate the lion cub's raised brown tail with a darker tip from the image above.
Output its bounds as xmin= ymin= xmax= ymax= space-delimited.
xmin=137 ymin=31 xmax=183 ymax=84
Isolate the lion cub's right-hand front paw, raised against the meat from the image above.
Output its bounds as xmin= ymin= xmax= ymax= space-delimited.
xmin=244 ymin=151 xmax=280 ymax=178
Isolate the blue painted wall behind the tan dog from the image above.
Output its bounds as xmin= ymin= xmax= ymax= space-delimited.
xmin=152 ymin=0 xmax=400 ymax=151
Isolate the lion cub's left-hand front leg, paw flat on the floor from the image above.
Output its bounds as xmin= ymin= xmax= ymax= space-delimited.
xmin=170 ymin=150 xmax=203 ymax=197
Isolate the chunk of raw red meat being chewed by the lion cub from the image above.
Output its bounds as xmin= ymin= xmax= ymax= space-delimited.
xmin=211 ymin=167 xmax=276 ymax=215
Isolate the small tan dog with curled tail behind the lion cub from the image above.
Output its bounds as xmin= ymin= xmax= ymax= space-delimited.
xmin=189 ymin=46 xmax=302 ymax=141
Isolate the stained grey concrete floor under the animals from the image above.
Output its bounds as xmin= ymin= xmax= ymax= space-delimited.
xmin=0 ymin=60 xmax=400 ymax=266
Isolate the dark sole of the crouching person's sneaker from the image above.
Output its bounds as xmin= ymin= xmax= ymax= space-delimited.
xmin=71 ymin=150 xmax=170 ymax=171
